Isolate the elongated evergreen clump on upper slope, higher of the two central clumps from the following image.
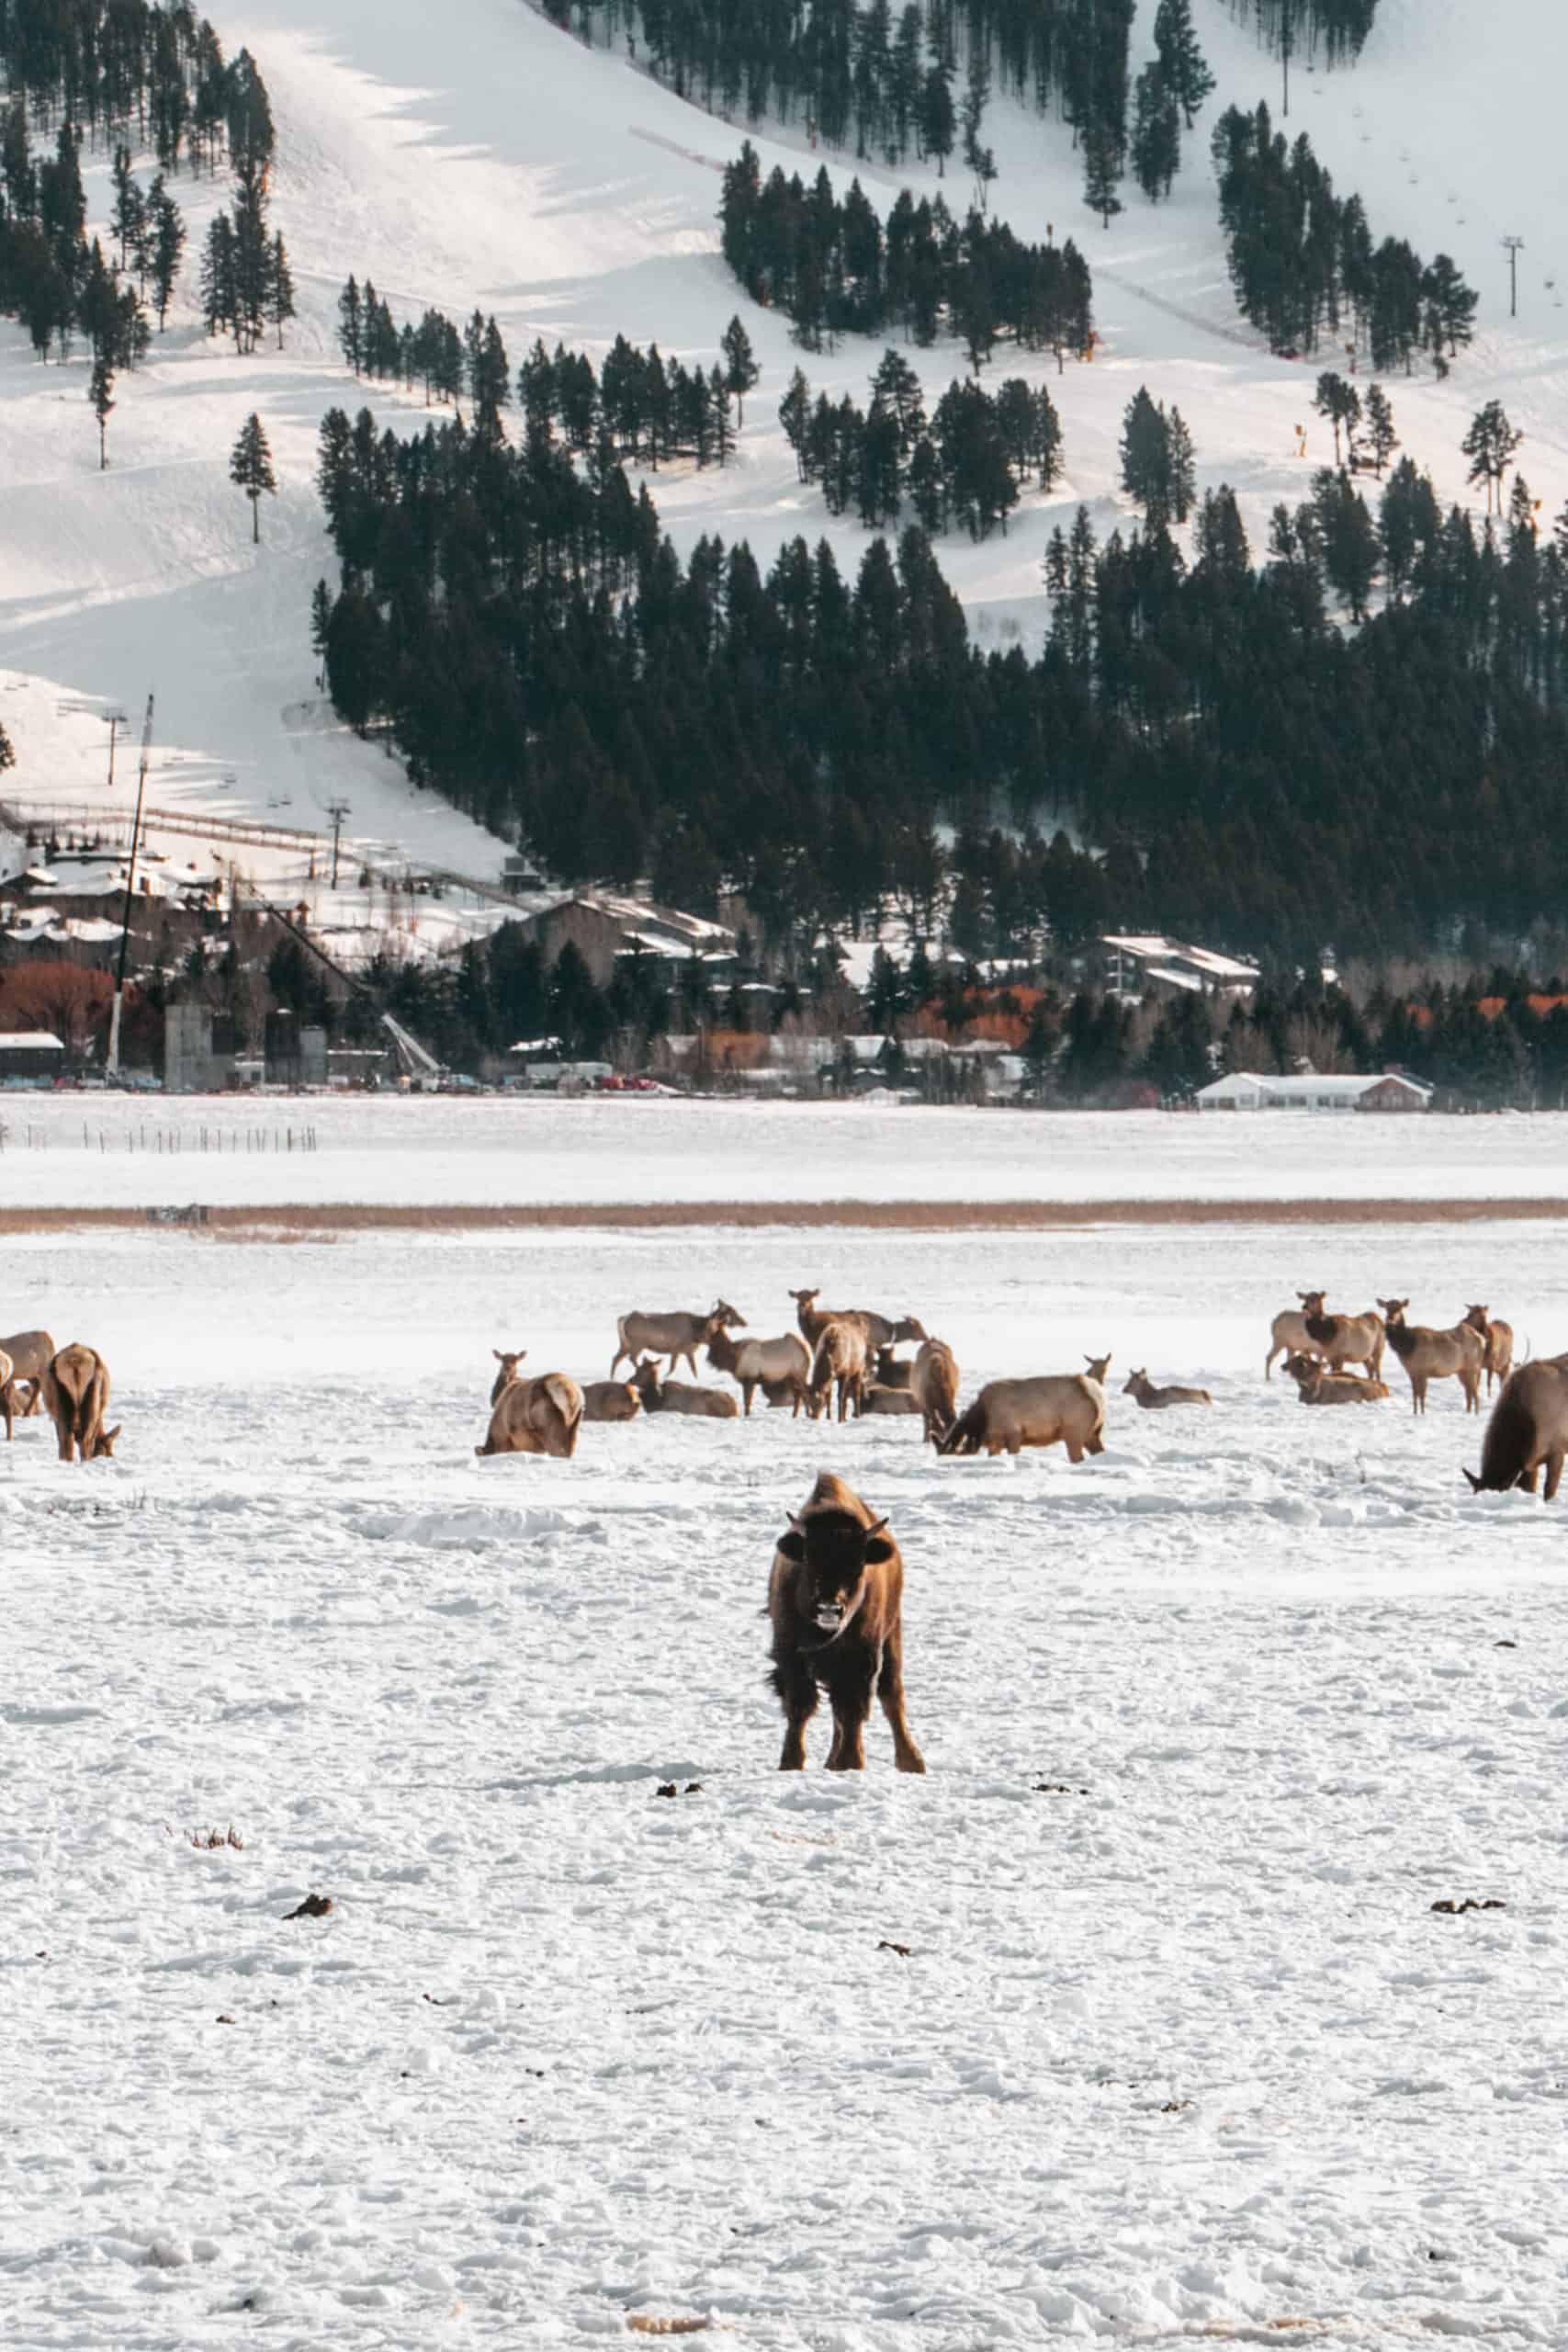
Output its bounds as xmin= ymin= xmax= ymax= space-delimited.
xmin=719 ymin=139 xmax=1093 ymax=371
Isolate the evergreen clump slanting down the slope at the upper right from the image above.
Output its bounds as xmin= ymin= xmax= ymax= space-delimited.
xmin=1213 ymin=106 xmax=1476 ymax=374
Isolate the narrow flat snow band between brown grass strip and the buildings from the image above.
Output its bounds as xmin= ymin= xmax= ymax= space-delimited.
xmin=0 ymin=1093 xmax=1568 ymax=1209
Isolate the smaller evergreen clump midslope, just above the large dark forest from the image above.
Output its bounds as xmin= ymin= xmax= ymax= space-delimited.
xmin=778 ymin=350 xmax=1063 ymax=538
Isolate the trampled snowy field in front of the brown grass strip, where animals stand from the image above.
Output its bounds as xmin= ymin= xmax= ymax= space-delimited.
xmin=0 ymin=1223 xmax=1568 ymax=2352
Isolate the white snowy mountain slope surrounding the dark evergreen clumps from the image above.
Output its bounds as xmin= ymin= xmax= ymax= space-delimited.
xmin=0 ymin=0 xmax=1568 ymax=873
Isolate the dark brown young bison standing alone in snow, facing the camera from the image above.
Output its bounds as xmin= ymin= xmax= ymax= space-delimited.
xmin=769 ymin=1470 xmax=926 ymax=1771
